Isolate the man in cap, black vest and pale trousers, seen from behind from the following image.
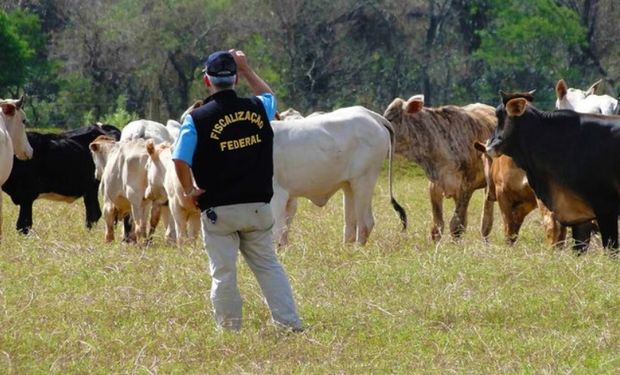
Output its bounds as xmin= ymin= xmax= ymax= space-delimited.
xmin=172 ymin=50 xmax=301 ymax=331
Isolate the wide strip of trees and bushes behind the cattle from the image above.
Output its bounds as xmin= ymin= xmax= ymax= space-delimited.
xmin=0 ymin=0 xmax=620 ymax=128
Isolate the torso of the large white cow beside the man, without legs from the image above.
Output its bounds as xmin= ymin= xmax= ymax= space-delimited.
xmin=272 ymin=106 xmax=389 ymax=196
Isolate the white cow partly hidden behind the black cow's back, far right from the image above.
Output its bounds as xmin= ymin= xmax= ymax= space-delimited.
xmin=555 ymin=79 xmax=620 ymax=115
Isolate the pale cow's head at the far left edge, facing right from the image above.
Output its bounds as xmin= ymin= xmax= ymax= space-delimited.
xmin=0 ymin=96 xmax=33 ymax=160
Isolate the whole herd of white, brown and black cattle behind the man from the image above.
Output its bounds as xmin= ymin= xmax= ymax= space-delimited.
xmin=0 ymin=80 xmax=620 ymax=251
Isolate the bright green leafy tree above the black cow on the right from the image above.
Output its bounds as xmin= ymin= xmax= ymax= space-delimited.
xmin=473 ymin=0 xmax=586 ymax=106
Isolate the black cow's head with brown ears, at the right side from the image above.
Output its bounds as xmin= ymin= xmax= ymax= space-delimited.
xmin=485 ymin=91 xmax=531 ymax=158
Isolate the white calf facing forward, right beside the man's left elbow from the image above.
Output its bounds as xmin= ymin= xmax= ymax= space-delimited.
xmin=146 ymin=141 xmax=200 ymax=246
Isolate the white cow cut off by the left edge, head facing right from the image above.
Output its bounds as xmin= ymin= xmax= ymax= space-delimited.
xmin=0 ymin=97 xmax=32 ymax=240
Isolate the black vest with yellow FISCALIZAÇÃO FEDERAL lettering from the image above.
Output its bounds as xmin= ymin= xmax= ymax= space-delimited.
xmin=191 ymin=90 xmax=273 ymax=210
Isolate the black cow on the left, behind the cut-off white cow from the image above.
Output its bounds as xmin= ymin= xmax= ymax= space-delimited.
xmin=2 ymin=125 xmax=121 ymax=234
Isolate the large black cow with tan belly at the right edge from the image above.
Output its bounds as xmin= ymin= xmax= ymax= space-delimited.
xmin=486 ymin=93 xmax=620 ymax=253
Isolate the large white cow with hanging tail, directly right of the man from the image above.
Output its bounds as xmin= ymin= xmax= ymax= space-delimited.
xmin=271 ymin=106 xmax=406 ymax=245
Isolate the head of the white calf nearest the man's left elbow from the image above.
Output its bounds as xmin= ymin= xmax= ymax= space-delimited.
xmin=144 ymin=139 xmax=171 ymax=203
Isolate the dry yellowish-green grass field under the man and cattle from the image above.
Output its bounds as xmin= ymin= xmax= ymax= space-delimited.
xmin=0 ymin=160 xmax=620 ymax=374
